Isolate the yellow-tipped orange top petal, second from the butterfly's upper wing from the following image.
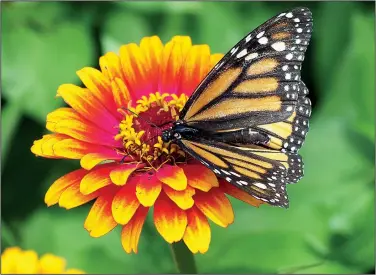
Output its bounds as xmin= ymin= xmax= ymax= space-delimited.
xmin=178 ymin=45 xmax=210 ymax=95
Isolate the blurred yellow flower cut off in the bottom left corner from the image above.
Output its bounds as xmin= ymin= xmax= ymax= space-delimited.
xmin=1 ymin=247 xmax=85 ymax=274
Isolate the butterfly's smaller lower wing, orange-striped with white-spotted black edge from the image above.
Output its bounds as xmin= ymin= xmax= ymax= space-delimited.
xmin=177 ymin=138 xmax=303 ymax=208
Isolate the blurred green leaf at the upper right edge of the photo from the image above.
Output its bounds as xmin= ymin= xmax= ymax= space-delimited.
xmin=321 ymin=10 xmax=375 ymax=129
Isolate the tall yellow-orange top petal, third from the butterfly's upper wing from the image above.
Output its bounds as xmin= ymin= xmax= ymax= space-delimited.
xmin=158 ymin=36 xmax=192 ymax=94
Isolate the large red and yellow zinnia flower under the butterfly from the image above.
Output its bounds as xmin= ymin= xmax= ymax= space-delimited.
xmin=31 ymin=36 xmax=262 ymax=253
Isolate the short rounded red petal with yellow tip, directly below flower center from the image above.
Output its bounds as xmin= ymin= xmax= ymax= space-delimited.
xmin=136 ymin=174 xmax=162 ymax=207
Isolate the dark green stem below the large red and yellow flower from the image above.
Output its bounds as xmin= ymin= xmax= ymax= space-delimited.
xmin=171 ymin=241 xmax=197 ymax=274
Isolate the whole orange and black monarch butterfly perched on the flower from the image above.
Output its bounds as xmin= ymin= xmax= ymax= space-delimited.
xmin=162 ymin=8 xmax=312 ymax=208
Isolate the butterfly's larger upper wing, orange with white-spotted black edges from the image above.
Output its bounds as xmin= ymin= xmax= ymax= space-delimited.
xmin=180 ymin=8 xmax=312 ymax=130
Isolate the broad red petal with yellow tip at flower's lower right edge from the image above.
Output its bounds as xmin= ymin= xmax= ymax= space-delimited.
xmin=194 ymin=188 xmax=234 ymax=227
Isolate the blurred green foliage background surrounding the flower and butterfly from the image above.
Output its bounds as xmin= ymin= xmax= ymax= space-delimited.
xmin=1 ymin=2 xmax=375 ymax=273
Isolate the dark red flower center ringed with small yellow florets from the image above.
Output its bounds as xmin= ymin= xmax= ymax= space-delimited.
xmin=115 ymin=92 xmax=188 ymax=169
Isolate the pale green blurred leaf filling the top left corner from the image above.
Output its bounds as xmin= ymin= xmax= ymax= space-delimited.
xmin=2 ymin=2 xmax=92 ymax=122
